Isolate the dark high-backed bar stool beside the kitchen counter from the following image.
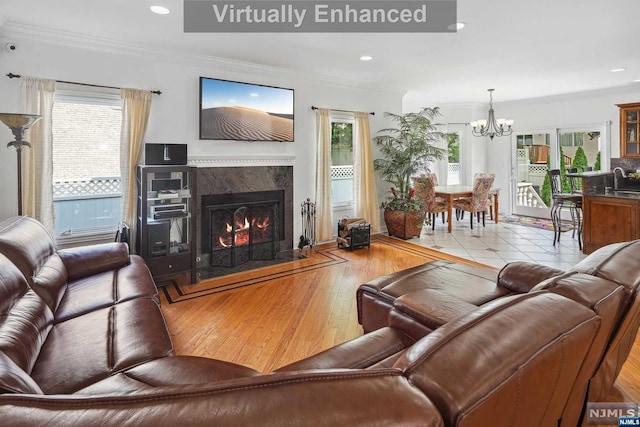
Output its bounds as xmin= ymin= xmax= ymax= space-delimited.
xmin=547 ymin=169 xmax=582 ymax=250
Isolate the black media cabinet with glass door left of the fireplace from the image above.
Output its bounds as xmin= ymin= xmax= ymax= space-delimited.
xmin=136 ymin=165 xmax=196 ymax=284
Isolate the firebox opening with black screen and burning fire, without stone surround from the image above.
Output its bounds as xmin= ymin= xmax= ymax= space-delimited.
xmin=202 ymin=191 xmax=284 ymax=267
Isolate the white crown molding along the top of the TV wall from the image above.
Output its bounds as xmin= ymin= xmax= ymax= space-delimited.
xmin=0 ymin=17 xmax=406 ymax=96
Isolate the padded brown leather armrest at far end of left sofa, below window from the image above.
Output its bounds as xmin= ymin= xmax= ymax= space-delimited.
xmin=58 ymin=243 xmax=130 ymax=281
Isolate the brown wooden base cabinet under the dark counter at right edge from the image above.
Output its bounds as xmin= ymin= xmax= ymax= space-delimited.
xmin=582 ymin=196 xmax=640 ymax=254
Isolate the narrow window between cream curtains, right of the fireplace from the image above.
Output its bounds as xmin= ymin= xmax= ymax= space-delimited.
xmin=331 ymin=116 xmax=354 ymax=206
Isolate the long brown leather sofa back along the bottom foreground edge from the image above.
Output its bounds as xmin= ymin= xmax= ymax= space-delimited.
xmin=0 ymin=369 xmax=444 ymax=427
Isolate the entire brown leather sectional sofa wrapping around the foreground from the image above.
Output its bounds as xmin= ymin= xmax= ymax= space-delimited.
xmin=0 ymin=217 xmax=640 ymax=426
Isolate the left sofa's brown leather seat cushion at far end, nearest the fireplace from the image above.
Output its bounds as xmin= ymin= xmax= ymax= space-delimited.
xmin=55 ymin=256 xmax=158 ymax=323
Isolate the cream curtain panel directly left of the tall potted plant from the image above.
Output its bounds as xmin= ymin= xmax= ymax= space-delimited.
xmin=353 ymin=112 xmax=380 ymax=231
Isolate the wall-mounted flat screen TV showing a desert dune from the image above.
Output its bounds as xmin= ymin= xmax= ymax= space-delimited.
xmin=200 ymin=77 xmax=293 ymax=142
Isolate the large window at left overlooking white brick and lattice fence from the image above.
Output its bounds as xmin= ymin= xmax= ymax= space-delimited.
xmin=52 ymin=90 xmax=122 ymax=242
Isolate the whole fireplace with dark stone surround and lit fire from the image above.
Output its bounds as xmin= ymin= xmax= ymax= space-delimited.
xmin=195 ymin=165 xmax=294 ymax=279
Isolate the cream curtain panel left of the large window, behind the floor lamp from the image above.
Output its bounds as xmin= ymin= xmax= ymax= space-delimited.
xmin=19 ymin=76 xmax=56 ymax=236
